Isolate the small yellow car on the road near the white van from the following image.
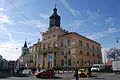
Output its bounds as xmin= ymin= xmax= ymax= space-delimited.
xmin=74 ymin=68 xmax=92 ymax=77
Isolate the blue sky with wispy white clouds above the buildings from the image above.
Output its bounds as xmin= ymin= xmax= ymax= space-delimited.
xmin=0 ymin=0 xmax=120 ymax=60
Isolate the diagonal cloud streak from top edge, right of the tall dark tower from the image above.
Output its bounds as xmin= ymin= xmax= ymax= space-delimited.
xmin=60 ymin=0 xmax=80 ymax=16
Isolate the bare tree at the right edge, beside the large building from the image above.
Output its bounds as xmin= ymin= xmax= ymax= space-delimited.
xmin=105 ymin=48 xmax=120 ymax=60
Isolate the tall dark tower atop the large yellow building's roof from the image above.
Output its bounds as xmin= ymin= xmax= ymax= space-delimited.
xmin=49 ymin=6 xmax=60 ymax=28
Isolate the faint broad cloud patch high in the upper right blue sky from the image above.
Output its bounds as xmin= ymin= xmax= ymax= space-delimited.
xmin=86 ymin=10 xmax=102 ymax=19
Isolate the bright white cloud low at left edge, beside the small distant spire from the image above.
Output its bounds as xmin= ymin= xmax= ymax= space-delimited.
xmin=0 ymin=41 xmax=23 ymax=60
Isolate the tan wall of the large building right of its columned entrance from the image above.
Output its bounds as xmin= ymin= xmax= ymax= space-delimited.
xmin=58 ymin=33 xmax=102 ymax=67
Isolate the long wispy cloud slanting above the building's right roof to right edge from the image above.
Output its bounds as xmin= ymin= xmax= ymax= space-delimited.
xmin=87 ymin=28 xmax=120 ymax=39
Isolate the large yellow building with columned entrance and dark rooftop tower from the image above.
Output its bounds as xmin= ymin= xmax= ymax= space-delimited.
xmin=21 ymin=8 xmax=102 ymax=68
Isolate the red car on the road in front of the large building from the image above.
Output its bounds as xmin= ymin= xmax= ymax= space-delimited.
xmin=35 ymin=69 xmax=55 ymax=78
